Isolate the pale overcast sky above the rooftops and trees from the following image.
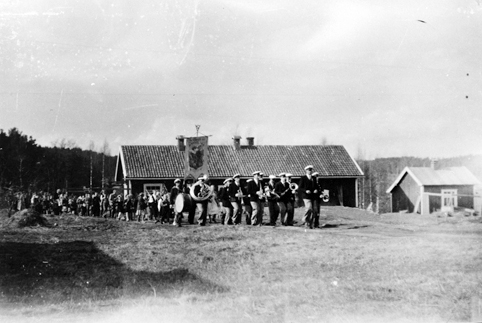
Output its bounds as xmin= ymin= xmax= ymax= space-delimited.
xmin=0 ymin=0 xmax=482 ymax=158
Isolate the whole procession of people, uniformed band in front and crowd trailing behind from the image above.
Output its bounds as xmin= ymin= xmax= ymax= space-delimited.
xmin=4 ymin=165 xmax=323 ymax=228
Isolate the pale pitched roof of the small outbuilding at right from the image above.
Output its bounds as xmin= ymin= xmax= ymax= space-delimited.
xmin=387 ymin=166 xmax=481 ymax=193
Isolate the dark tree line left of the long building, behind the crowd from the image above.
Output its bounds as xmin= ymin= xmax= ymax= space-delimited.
xmin=0 ymin=128 xmax=116 ymax=196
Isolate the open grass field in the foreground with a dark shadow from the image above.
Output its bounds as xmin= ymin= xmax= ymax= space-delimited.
xmin=0 ymin=207 xmax=482 ymax=323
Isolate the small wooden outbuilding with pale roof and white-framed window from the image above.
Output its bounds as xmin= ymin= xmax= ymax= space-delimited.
xmin=387 ymin=166 xmax=481 ymax=214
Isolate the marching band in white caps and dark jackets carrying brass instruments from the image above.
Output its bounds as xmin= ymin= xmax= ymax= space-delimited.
xmin=166 ymin=165 xmax=324 ymax=229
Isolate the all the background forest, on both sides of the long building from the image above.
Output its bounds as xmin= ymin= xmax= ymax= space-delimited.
xmin=0 ymin=128 xmax=482 ymax=213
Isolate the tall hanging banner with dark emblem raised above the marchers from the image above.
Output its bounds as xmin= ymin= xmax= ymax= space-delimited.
xmin=184 ymin=136 xmax=209 ymax=179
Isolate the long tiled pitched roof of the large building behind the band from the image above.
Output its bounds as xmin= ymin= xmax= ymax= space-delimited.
xmin=116 ymin=145 xmax=363 ymax=179
